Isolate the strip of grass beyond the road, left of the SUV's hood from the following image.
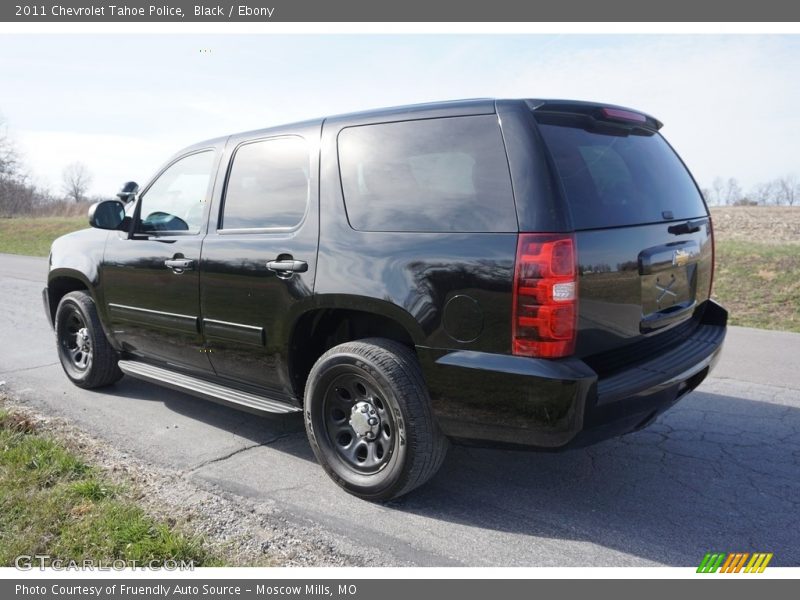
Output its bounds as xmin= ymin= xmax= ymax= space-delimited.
xmin=0 ymin=216 xmax=89 ymax=256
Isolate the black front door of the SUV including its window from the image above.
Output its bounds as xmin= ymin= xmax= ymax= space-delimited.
xmin=101 ymin=149 xmax=222 ymax=372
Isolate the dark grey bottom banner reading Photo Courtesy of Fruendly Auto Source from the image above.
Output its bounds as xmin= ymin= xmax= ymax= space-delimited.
xmin=0 ymin=576 xmax=797 ymax=600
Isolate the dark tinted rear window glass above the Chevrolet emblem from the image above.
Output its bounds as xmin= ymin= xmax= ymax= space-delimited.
xmin=539 ymin=123 xmax=706 ymax=229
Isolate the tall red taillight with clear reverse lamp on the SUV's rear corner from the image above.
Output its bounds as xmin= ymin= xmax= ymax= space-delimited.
xmin=511 ymin=233 xmax=578 ymax=358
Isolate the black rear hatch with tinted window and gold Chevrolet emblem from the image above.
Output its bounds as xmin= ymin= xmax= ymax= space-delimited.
xmin=532 ymin=102 xmax=713 ymax=368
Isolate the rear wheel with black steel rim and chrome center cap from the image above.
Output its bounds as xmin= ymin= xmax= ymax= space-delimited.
xmin=304 ymin=338 xmax=448 ymax=501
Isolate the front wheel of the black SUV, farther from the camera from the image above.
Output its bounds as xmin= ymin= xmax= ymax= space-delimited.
xmin=55 ymin=291 xmax=122 ymax=389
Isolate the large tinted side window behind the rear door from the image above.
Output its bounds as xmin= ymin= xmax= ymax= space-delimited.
xmin=338 ymin=115 xmax=517 ymax=232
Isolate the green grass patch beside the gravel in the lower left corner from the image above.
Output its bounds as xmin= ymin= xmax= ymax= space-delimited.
xmin=0 ymin=409 xmax=216 ymax=566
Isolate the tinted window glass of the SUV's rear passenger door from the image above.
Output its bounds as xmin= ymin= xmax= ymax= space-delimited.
xmin=222 ymin=137 xmax=309 ymax=229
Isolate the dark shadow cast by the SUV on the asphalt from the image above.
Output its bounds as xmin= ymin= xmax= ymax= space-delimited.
xmin=101 ymin=378 xmax=800 ymax=566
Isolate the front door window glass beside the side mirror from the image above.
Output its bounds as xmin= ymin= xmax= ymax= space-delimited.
xmin=139 ymin=150 xmax=214 ymax=233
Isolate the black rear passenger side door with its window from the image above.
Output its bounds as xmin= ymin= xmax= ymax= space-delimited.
xmin=200 ymin=127 xmax=319 ymax=399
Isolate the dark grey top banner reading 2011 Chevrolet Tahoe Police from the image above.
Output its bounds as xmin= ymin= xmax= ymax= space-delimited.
xmin=0 ymin=0 xmax=800 ymax=23
